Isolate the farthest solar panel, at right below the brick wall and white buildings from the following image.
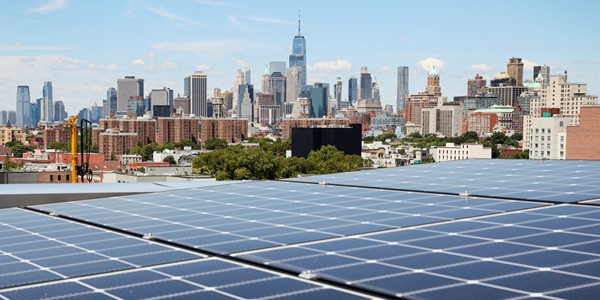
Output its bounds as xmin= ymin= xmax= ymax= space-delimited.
xmin=286 ymin=159 xmax=600 ymax=203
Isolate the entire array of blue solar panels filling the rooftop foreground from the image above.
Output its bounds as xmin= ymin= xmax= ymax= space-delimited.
xmin=0 ymin=160 xmax=600 ymax=299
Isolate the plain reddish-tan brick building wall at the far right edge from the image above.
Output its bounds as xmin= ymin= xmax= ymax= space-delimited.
xmin=565 ymin=106 xmax=600 ymax=160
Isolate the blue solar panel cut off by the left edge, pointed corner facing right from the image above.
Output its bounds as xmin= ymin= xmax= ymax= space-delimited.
xmin=0 ymin=208 xmax=203 ymax=288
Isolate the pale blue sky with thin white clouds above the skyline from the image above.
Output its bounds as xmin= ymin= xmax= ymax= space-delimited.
xmin=0 ymin=0 xmax=600 ymax=114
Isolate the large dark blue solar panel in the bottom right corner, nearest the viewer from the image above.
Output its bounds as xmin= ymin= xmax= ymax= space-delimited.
xmin=234 ymin=204 xmax=600 ymax=299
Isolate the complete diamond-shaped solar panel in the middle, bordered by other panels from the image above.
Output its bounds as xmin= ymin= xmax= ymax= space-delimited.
xmin=30 ymin=181 xmax=543 ymax=254
